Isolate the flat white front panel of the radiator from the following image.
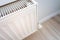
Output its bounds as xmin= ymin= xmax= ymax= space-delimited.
xmin=0 ymin=4 xmax=37 ymax=40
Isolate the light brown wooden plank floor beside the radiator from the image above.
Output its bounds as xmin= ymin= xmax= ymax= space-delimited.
xmin=24 ymin=15 xmax=60 ymax=40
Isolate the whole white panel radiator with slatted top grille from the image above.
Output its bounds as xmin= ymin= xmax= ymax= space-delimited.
xmin=0 ymin=0 xmax=38 ymax=40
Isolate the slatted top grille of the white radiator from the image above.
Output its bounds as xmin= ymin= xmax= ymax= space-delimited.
xmin=0 ymin=1 xmax=32 ymax=17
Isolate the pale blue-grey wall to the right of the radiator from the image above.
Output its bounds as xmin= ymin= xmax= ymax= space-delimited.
xmin=36 ymin=0 xmax=60 ymax=20
